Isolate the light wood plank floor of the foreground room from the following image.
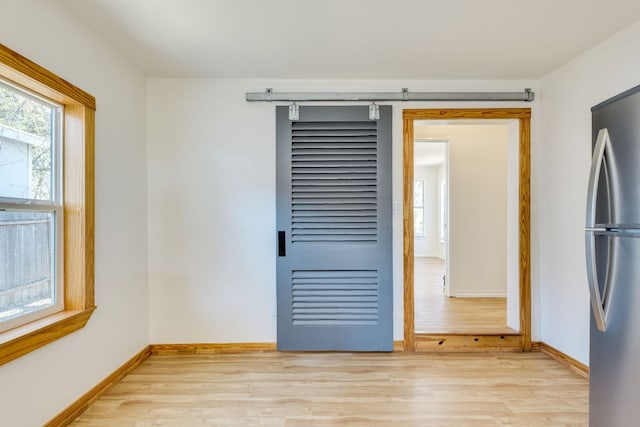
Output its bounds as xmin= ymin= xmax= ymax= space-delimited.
xmin=71 ymin=352 xmax=588 ymax=427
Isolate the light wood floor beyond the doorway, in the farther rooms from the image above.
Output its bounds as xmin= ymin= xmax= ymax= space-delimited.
xmin=414 ymin=257 xmax=516 ymax=334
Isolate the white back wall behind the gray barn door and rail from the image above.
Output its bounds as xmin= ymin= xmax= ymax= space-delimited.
xmin=147 ymin=79 xmax=538 ymax=343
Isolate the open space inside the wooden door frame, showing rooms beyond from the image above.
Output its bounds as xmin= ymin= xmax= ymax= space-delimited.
xmin=413 ymin=125 xmax=519 ymax=334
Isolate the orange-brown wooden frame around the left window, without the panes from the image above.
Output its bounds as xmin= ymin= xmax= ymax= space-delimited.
xmin=0 ymin=44 xmax=96 ymax=365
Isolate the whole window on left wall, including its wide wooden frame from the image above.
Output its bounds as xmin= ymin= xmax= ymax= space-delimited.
xmin=0 ymin=44 xmax=95 ymax=364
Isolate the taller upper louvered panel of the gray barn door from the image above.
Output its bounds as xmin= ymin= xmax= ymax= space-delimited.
xmin=291 ymin=120 xmax=378 ymax=244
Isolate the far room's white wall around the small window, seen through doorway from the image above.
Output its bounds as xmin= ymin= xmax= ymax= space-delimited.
xmin=414 ymin=166 xmax=440 ymax=257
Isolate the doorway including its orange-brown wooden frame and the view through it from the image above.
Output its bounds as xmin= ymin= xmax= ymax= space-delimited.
xmin=403 ymin=109 xmax=531 ymax=351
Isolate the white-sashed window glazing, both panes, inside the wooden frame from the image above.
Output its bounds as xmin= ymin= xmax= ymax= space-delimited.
xmin=0 ymin=80 xmax=64 ymax=331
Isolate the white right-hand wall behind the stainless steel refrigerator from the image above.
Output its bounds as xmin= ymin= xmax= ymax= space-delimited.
xmin=539 ymin=18 xmax=640 ymax=363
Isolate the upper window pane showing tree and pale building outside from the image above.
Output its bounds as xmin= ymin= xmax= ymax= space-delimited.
xmin=0 ymin=82 xmax=57 ymax=200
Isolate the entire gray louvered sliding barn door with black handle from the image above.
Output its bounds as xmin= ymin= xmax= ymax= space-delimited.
xmin=276 ymin=106 xmax=393 ymax=351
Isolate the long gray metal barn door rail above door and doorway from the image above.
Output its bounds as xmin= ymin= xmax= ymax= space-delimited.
xmin=246 ymin=88 xmax=535 ymax=102
